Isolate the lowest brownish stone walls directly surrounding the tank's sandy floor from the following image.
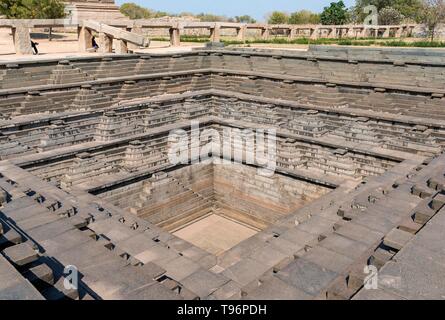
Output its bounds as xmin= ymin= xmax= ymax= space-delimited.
xmin=101 ymin=164 xmax=330 ymax=230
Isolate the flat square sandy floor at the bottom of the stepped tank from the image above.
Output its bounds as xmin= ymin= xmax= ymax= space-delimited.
xmin=174 ymin=214 xmax=257 ymax=255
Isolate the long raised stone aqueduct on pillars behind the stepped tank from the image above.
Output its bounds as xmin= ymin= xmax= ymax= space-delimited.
xmin=0 ymin=18 xmax=418 ymax=54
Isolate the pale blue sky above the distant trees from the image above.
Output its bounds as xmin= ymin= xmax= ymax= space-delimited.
xmin=116 ymin=0 xmax=355 ymax=21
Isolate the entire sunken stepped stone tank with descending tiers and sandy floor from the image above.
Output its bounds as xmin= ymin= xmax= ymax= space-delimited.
xmin=0 ymin=47 xmax=445 ymax=300
